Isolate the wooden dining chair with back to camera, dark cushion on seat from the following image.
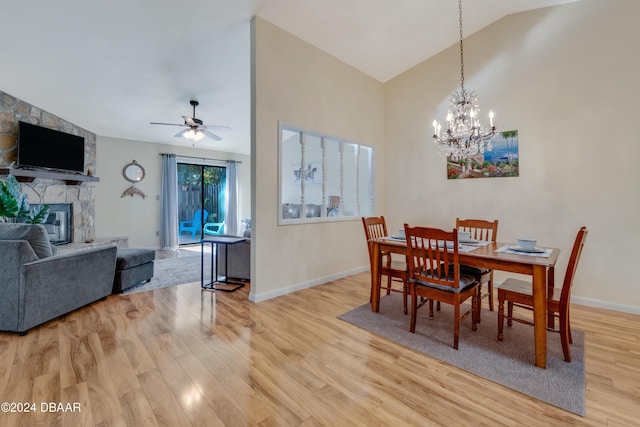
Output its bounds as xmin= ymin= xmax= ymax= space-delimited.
xmin=404 ymin=224 xmax=480 ymax=350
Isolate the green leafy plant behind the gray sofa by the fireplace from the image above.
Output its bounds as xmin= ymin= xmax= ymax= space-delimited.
xmin=0 ymin=175 xmax=49 ymax=224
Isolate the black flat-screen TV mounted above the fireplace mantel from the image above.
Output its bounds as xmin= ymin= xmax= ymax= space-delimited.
xmin=18 ymin=121 xmax=84 ymax=173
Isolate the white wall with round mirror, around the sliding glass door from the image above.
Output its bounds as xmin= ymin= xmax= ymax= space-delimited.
xmin=96 ymin=136 xmax=251 ymax=248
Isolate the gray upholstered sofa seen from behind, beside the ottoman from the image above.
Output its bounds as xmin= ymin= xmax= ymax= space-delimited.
xmin=0 ymin=223 xmax=116 ymax=334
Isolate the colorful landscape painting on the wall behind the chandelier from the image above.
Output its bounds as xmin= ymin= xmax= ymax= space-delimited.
xmin=447 ymin=130 xmax=520 ymax=179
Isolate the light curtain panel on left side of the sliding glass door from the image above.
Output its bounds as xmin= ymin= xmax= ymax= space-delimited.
xmin=160 ymin=154 xmax=179 ymax=250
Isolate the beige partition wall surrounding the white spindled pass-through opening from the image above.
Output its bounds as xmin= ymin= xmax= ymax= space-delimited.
xmin=250 ymin=18 xmax=384 ymax=301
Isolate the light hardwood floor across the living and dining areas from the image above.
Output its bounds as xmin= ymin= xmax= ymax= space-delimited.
xmin=0 ymin=273 xmax=640 ymax=427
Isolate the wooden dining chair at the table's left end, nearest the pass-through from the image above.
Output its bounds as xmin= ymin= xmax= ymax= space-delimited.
xmin=362 ymin=216 xmax=409 ymax=314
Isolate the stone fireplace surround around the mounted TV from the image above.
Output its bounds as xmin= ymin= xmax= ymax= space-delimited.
xmin=0 ymin=91 xmax=98 ymax=243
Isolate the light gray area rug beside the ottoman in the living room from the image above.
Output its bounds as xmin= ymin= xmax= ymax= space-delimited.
xmin=123 ymin=252 xmax=211 ymax=294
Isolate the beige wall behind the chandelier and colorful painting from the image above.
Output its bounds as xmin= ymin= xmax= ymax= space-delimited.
xmin=383 ymin=0 xmax=640 ymax=313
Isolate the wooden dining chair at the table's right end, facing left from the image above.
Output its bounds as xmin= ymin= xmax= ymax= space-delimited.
xmin=498 ymin=227 xmax=588 ymax=362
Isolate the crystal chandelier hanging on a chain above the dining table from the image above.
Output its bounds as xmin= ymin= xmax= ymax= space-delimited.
xmin=433 ymin=0 xmax=496 ymax=159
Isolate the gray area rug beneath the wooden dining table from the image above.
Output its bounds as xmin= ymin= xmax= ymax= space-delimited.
xmin=338 ymin=294 xmax=585 ymax=416
